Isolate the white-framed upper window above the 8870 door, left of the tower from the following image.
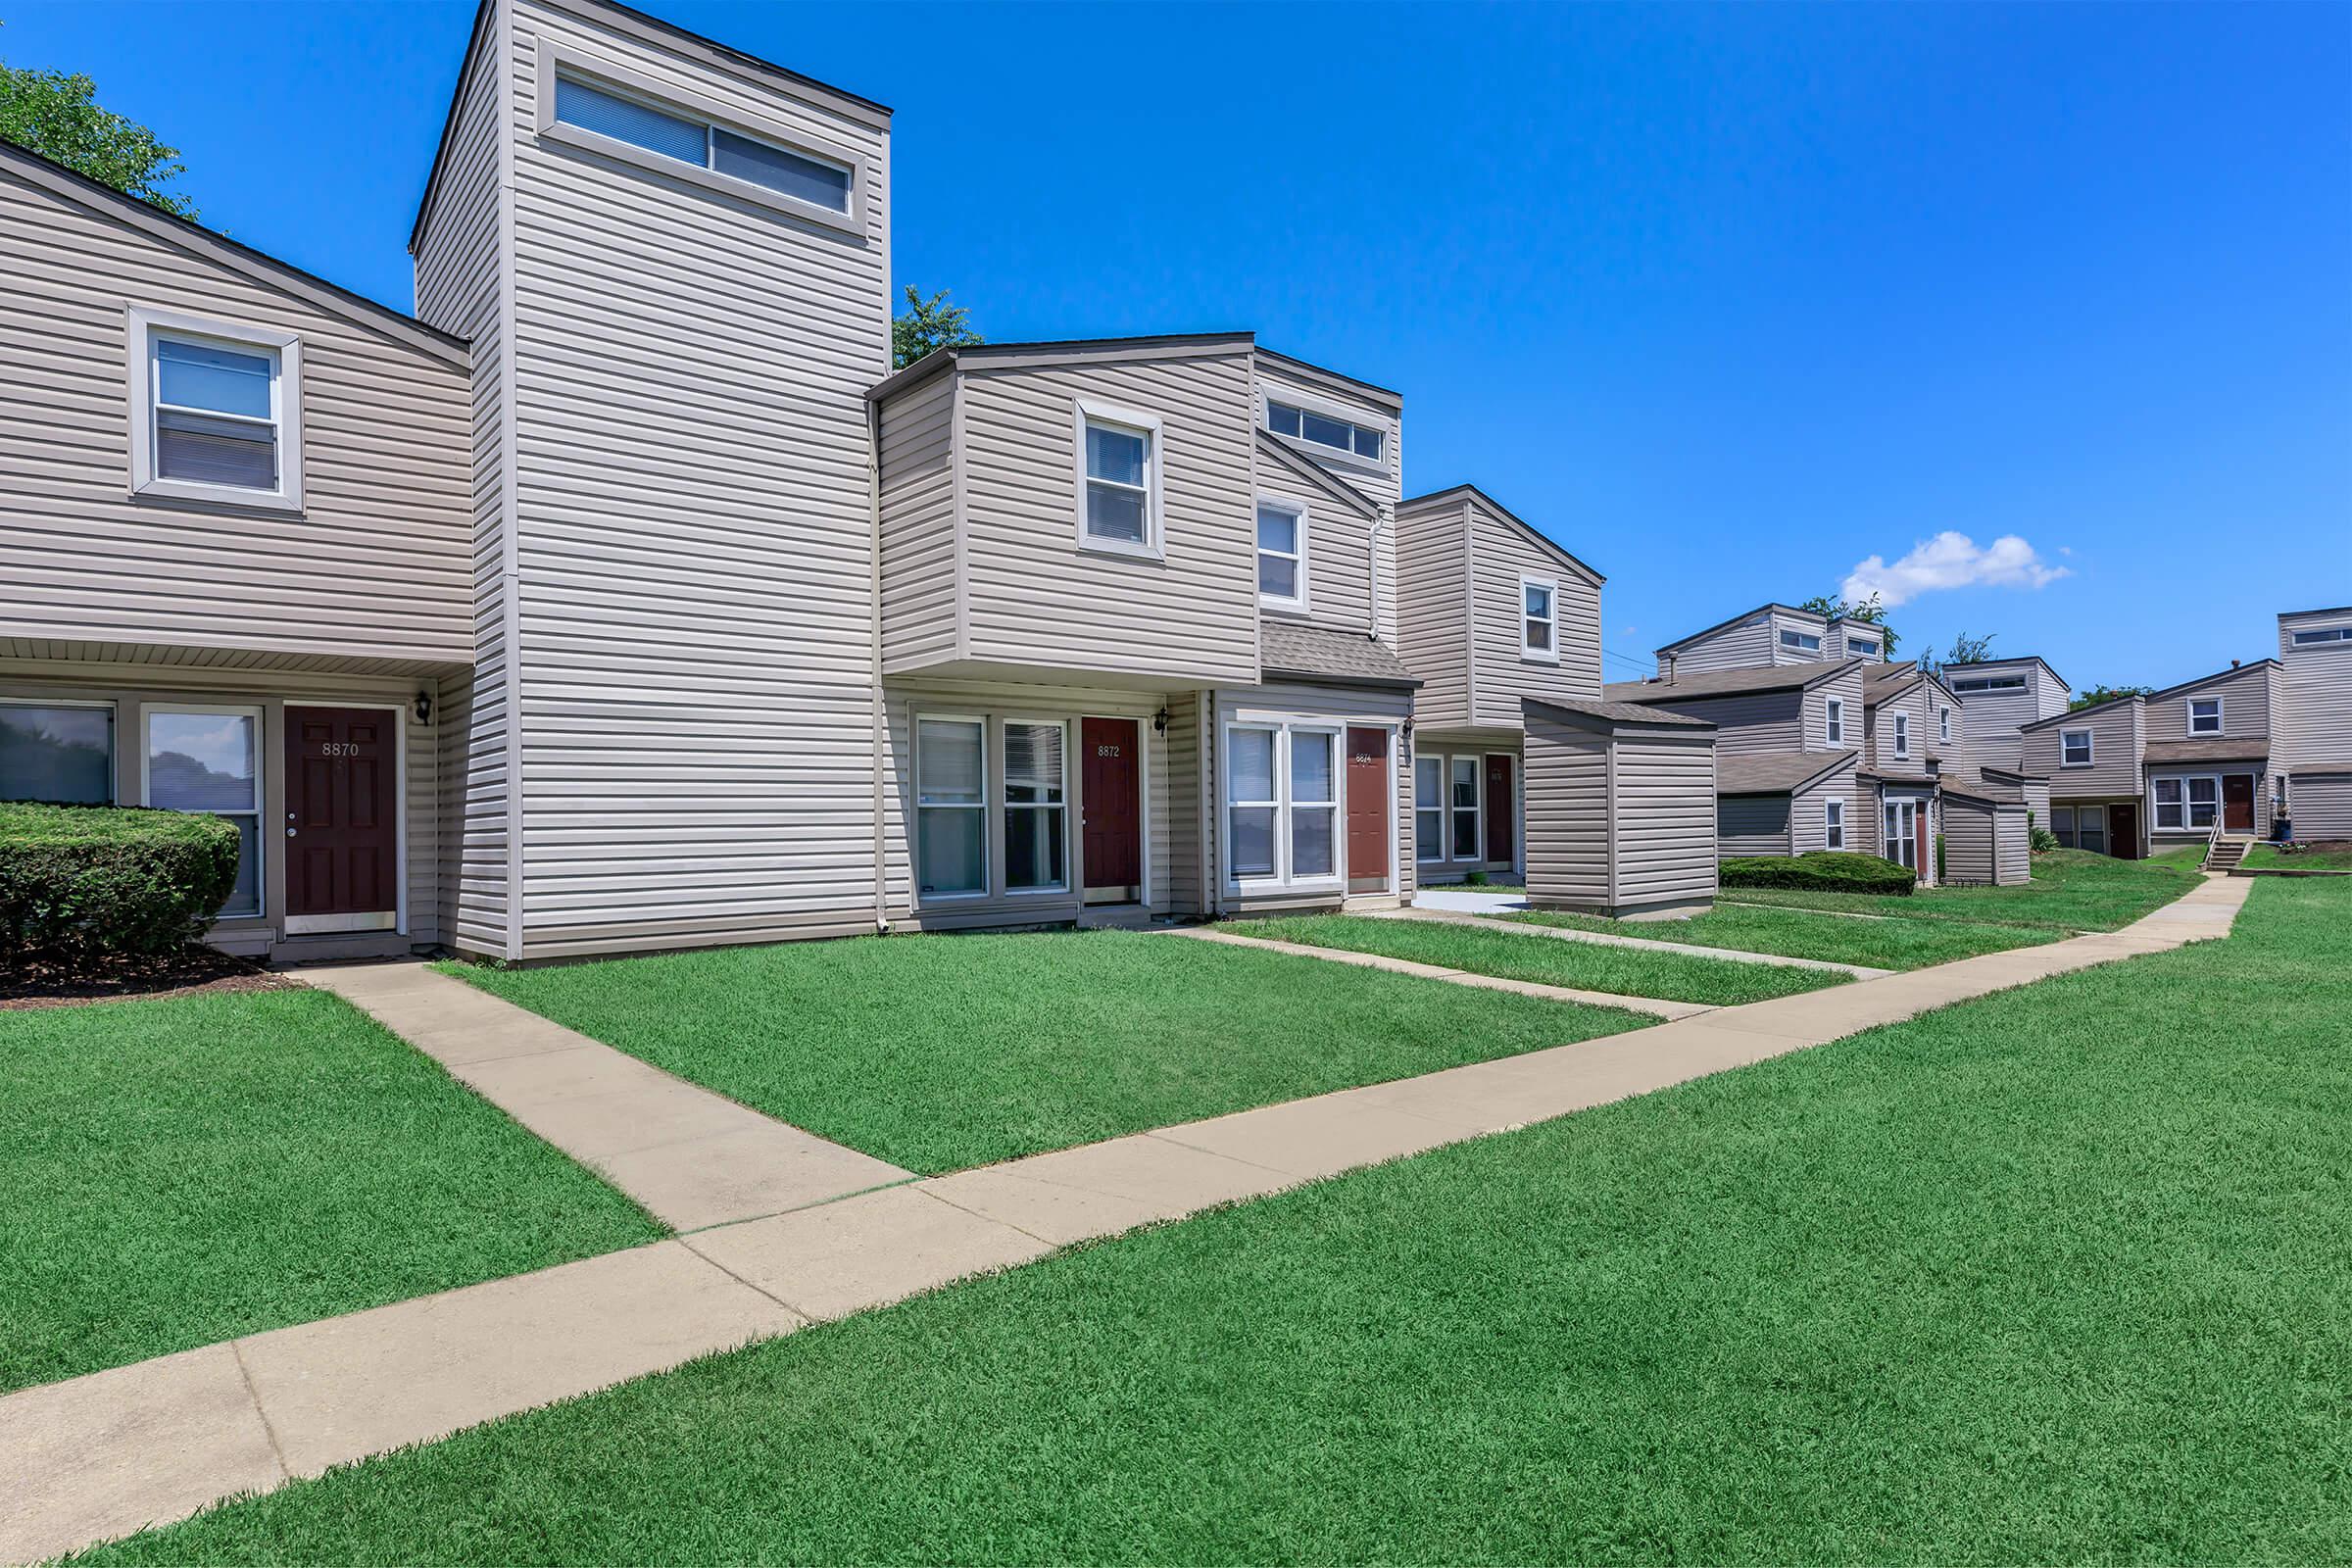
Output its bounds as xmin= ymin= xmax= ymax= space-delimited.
xmin=129 ymin=308 xmax=301 ymax=511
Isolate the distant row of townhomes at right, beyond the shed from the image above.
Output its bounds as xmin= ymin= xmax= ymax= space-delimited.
xmin=1606 ymin=604 xmax=2352 ymax=884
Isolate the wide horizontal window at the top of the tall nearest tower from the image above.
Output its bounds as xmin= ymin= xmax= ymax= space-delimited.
xmin=539 ymin=40 xmax=860 ymax=228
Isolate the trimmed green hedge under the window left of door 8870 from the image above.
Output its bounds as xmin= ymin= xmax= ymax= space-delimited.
xmin=0 ymin=804 xmax=237 ymax=961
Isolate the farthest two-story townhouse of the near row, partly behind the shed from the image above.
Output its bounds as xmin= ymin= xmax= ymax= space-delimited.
xmin=1395 ymin=484 xmax=1604 ymax=884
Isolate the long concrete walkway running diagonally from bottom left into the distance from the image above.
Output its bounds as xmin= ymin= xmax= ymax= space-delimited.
xmin=0 ymin=877 xmax=2253 ymax=1563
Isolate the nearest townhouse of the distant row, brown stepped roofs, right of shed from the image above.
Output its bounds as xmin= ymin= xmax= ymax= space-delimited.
xmin=1604 ymin=659 xmax=1877 ymax=856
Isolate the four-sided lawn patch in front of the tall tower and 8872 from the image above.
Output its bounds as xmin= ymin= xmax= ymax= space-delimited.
xmin=449 ymin=931 xmax=1653 ymax=1173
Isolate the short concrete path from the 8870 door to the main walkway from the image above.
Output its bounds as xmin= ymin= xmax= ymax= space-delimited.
xmin=296 ymin=964 xmax=912 ymax=1230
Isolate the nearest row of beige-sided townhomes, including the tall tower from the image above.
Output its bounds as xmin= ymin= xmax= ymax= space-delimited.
xmin=0 ymin=0 xmax=1715 ymax=961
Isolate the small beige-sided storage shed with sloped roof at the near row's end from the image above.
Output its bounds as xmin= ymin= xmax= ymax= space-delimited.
xmin=1522 ymin=698 xmax=1717 ymax=917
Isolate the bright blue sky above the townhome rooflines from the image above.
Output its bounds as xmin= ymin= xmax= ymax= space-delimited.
xmin=0 ymin=0 xmax=2352 ymax=686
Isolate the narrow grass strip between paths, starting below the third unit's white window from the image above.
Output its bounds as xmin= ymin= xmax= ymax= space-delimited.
xmin=1223 ymin=914 xmax=1848 ymax=1004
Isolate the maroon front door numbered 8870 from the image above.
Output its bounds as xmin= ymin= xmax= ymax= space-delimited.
xmin=287 ymin=708 xmax=400 ymax=931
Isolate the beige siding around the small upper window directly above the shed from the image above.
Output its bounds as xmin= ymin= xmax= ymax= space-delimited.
xmin=1470 ymin=499 xmax=1601 ymax=729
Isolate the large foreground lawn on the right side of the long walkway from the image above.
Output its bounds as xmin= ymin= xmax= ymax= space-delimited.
xmin=119 ymin=879 xmax=2352 ymax=1563
